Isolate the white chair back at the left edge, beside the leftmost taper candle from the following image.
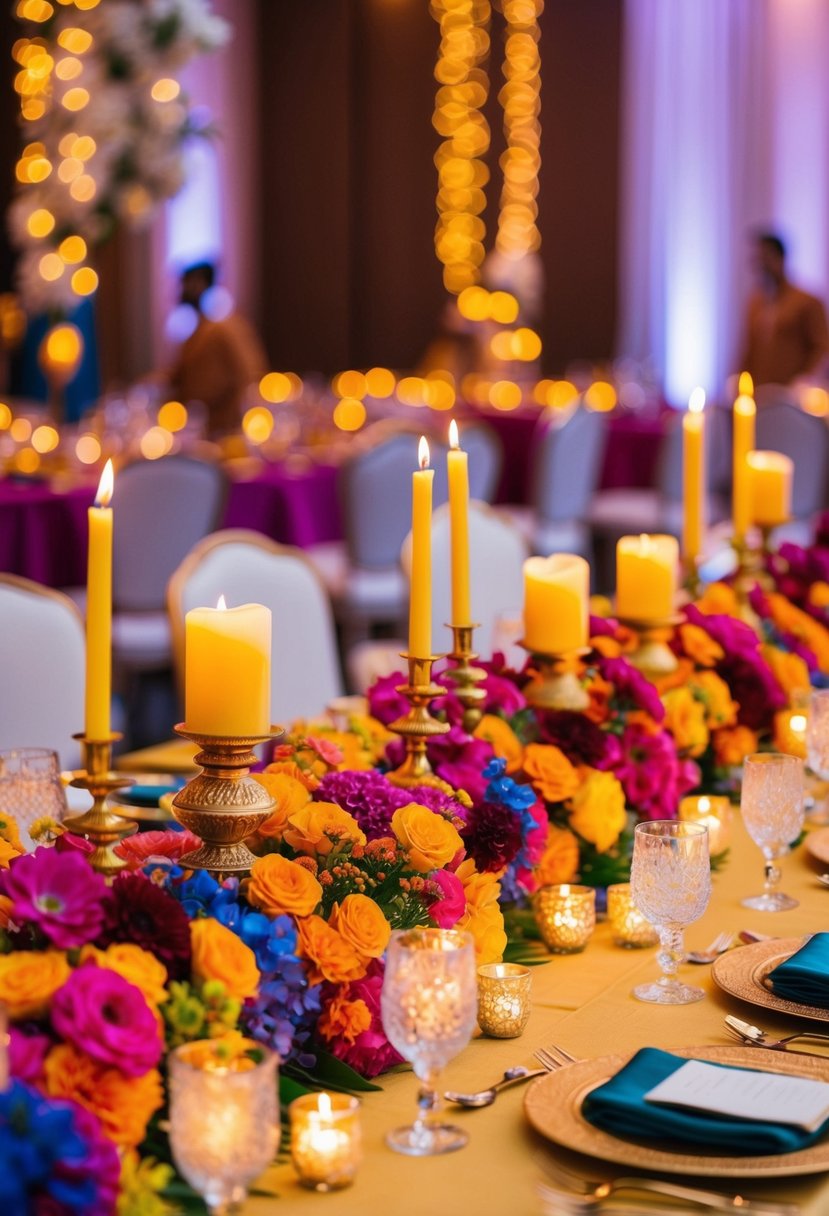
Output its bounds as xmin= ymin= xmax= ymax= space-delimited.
xmin=0 ymin=574 xmax=85 ymax=769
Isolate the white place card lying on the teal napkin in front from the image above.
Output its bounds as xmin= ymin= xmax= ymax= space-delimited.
xmin=644 ymin=1060 xmax=829 ymax=1132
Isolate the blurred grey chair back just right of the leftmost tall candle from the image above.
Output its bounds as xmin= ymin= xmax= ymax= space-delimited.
xmin=112 ymin=456 xmax=227 ymax=612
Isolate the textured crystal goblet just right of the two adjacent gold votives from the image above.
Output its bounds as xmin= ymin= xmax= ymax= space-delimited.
xmin=631 ymin=820 xmax=711 ymax=1004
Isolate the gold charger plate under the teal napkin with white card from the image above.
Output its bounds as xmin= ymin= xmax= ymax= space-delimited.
xmin=524 ymin=1043 xmax=829 ymax=1178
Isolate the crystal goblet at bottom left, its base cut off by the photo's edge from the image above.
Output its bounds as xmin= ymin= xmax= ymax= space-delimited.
xmin=169 ymin=1042 xmax=280 ymax=1216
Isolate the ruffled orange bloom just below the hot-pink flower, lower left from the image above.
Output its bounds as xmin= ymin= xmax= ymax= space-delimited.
xmin=44 ymin=1043 xmax=164 ymax=1148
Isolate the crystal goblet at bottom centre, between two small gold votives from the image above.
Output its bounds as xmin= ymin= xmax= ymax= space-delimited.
xmin=380 ymin=929 xmax=478 ymax=1156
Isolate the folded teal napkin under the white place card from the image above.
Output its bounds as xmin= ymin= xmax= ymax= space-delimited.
xmin=581 ymin=1047 xmax=829 ymax=1156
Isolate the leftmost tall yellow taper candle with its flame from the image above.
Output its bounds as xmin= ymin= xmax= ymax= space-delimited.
xmin=85 ymin=460 xmax=113 ymax=739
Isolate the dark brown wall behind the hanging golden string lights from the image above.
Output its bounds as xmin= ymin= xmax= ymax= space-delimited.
xmin=259 ymin=0 xmax=621 ymax=371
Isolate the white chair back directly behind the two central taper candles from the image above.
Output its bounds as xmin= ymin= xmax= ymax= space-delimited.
xmin=401 ymin=500 xmax=529 ymax=659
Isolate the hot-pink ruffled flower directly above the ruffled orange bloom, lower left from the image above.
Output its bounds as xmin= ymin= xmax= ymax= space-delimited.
xmin=52 ymin=964 xmax=162 ymax=1076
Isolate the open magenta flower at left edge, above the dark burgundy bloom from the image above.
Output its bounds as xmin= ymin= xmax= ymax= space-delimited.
xmin=0 ymin=848 xmax=109 ymax=950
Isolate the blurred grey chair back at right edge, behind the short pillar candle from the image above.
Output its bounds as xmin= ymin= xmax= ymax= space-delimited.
xmin=756 ymin=401 xmax=829 ymax=519
